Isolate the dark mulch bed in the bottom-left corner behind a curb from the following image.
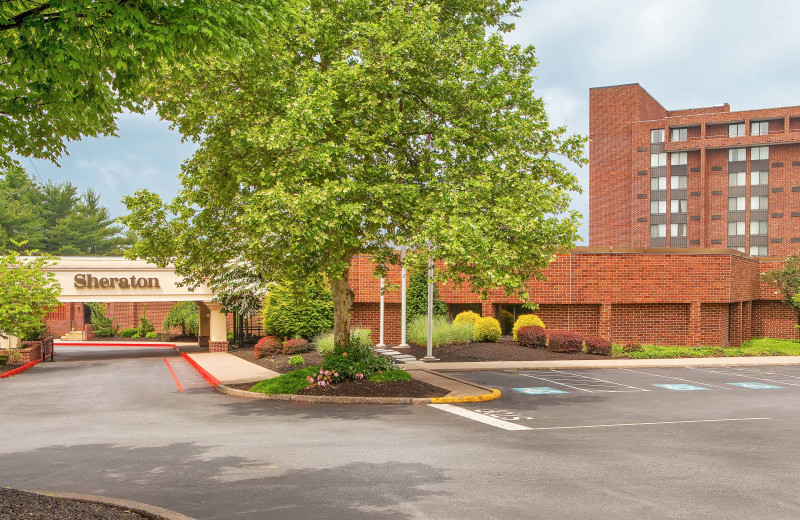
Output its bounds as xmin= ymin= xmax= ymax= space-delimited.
xmin=0 ymin=488 xmax=147 ymax=520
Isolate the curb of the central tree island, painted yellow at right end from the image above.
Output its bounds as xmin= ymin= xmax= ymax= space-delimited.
xmin=216 ymin=378 xmax=501 ymax=404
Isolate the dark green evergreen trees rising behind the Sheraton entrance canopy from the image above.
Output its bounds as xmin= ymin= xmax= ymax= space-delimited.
xmin=0 ymin=166 xmax=135 ymax=256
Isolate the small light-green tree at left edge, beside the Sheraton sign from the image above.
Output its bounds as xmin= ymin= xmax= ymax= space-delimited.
xmin=0 ymin=251 xmax=61 ymax=338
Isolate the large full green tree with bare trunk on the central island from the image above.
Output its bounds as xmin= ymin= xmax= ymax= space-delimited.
xmin=124 ymin=0 xmax=585 ymax=343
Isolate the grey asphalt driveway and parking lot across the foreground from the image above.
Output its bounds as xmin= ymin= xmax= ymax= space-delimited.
xmin=0 ymin=356 xmax=800 ymax=520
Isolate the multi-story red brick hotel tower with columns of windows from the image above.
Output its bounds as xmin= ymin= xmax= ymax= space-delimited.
xmin=589 ymin=84 xmax=800 ymax=257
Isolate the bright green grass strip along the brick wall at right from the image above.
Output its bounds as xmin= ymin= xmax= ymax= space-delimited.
xmin=612 ymin=338 xmax=800 ymax=359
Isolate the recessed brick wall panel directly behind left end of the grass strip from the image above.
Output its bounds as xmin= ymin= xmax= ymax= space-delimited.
xmin=608 ymin=303 xmax=689 ymax=345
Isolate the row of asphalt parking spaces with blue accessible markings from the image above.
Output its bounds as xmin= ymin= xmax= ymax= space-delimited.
xmin=434 ymin=366 xmax=800 ymax=431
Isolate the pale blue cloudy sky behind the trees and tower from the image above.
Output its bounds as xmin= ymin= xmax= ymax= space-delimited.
xmin=22 ymin=0 xmax=800 ymax=245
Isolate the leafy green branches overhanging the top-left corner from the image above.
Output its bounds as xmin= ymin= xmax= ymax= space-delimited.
xmin=0 ymin=0 xmax=279 ymax=167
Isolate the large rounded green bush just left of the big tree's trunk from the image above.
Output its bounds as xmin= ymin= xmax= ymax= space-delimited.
xmin=262 ymin=284 xmax=333 ymax=339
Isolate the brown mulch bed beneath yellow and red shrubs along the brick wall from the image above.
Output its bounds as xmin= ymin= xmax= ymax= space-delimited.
xmin=406 ymin=338 xmax=609 ymax=362
